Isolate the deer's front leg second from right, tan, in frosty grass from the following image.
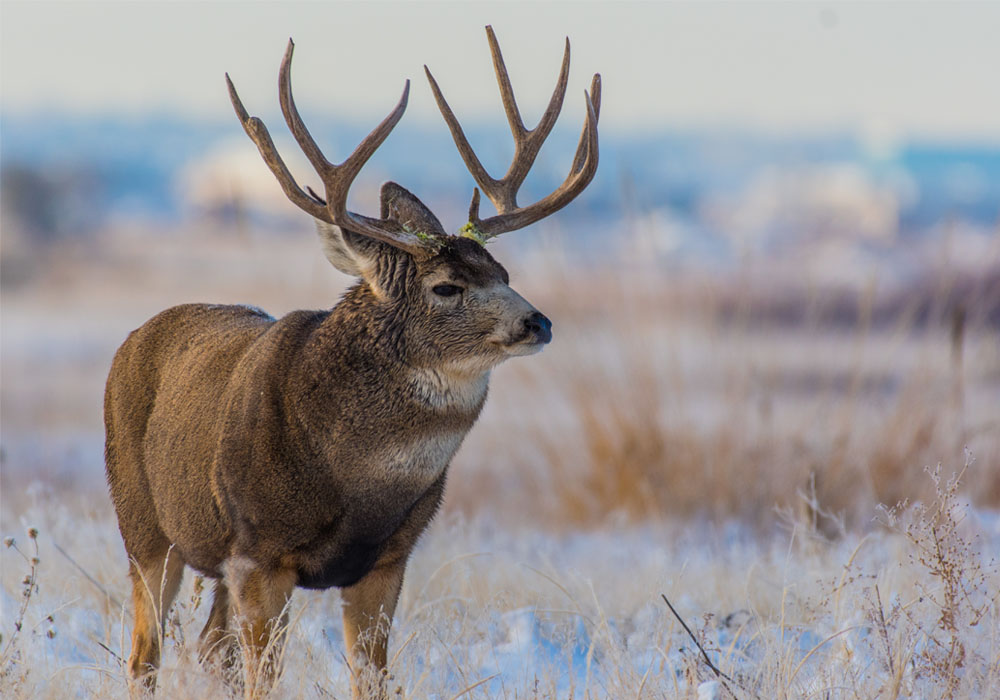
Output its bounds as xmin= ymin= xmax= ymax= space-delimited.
xmin=226 ymin=557 xmax=298 ymax=698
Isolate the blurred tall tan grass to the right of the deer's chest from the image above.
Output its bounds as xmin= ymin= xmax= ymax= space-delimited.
xmin=450 ymin=247 xmax=1000 ymax=534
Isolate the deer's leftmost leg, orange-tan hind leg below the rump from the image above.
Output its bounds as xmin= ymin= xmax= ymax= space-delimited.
xmin=128 ymin=545 xmax=184 ymax=691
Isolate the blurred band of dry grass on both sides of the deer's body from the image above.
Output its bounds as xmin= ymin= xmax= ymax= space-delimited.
xmin=2 ymin=224 xmax=1000 ymax=528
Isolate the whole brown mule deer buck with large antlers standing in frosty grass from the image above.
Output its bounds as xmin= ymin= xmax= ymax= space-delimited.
xmin=104 ymin=27 xmax=601 ymax=697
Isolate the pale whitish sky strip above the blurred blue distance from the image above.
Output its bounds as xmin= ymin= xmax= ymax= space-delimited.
xmin=0 ymin=0 xmax=1000 ymax=143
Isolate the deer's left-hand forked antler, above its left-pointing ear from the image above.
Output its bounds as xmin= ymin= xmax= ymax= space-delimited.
xmin=226 ymin=39 xmax=426 ymax=254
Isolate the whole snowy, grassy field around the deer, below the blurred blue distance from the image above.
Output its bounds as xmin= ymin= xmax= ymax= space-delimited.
xmin=0 ymin=227 xmax=1000 ymax=700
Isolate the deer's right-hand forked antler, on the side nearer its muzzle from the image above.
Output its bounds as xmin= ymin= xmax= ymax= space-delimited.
xmin=424 ymin=26 xmax=601 ymax=242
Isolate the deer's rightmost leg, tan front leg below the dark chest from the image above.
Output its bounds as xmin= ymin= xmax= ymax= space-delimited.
xmin=341 ymin=557 xmax=406 ymax=699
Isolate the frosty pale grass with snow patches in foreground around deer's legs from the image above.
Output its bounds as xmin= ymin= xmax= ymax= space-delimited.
xmin=0 ymin=467 xmax=1000 ymax=699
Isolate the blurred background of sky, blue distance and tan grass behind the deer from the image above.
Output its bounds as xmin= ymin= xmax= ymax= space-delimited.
xmin=0 ymin=1 xmax=1000 ymax=533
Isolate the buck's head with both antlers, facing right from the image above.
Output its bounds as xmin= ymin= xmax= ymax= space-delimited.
xmin=226 ymin=27 xmax=601 ymax=373
